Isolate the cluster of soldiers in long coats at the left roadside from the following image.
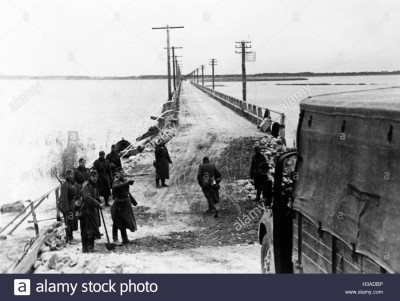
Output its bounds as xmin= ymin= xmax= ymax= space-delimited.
xmin=59 ymin=145 xmax=137 ymax=253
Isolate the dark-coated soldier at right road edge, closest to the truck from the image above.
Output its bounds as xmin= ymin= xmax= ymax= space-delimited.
xmin=250 ymin=146 xmax=272 ymax=205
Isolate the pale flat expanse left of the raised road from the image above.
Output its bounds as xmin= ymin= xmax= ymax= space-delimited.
xmin=0 ymin=80 xmax=166 ymax=207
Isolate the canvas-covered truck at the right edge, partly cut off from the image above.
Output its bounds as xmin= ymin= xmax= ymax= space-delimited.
xmin=259 ymin=87 xmax=400 ymax=273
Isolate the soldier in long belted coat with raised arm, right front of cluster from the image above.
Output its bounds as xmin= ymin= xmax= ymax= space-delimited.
xmin=111 ymin=167 xmax=137 ymax=244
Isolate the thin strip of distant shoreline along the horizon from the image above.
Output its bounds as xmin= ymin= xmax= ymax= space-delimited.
xmin=0 ymin=70 xmax=400 ymax=81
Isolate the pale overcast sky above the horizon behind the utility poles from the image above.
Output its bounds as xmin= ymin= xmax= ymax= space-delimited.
xmin=0 ymin=0 xmax=400 ymax=76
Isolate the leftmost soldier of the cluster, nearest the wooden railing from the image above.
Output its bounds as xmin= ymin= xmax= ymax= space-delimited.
xmin=59 ymin=170 xmax=80 ymax=245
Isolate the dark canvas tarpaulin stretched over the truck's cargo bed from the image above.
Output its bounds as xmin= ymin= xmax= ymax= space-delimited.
xmin=294 ymin=88 xmax=400 ymax=272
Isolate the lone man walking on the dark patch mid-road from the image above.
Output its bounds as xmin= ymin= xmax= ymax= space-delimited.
xmin=197 ymin=157 xmax=222 ymax=218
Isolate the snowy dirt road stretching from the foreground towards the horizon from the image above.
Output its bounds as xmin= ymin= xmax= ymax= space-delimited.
xmin=39 ymin=82 xmax=261 ymax=273
